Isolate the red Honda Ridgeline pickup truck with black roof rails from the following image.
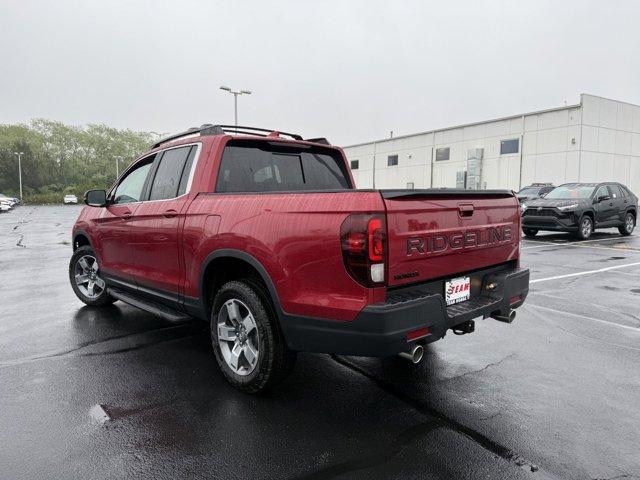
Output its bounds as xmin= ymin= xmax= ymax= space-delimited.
xmin=69 ymin=125 xmax=529 ymax=392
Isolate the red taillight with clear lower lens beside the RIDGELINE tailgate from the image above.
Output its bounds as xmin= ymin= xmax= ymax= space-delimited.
xmin=340 ymin=213 xmax=387 ymax=287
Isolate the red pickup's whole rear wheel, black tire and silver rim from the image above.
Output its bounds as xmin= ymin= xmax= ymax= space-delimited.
xmin=211 ymin=280 xmax=296 ymax=393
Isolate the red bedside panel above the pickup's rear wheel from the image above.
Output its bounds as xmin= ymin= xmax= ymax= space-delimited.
xmin=183 ymin=190 xmax=385 ymax=320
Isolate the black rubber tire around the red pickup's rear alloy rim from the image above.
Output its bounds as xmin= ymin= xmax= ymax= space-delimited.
xmin=211 ymin=279 xmax=296 ymax=393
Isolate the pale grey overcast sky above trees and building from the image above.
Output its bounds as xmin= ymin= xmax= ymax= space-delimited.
xmin=0 ymin=0 xmax=640 ymax=145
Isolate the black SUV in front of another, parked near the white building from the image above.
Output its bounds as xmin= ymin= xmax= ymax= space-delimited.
xmin=522 ymin=183 xmax=638 ymax=240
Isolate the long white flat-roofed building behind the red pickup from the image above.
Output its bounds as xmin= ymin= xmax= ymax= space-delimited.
xmin=344 ymin=94 xmax=640 ymax=194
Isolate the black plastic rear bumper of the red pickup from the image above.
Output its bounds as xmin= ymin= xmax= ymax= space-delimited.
xmin=282 ymin=269 xmax=529 ymax=357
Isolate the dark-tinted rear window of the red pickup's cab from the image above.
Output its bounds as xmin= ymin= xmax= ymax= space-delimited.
xmin=216 ymin=141 xmax=350 ymax=192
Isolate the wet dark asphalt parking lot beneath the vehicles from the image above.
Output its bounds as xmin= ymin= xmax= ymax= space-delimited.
xmin=0 ymin=206 xmax=640 ymax=479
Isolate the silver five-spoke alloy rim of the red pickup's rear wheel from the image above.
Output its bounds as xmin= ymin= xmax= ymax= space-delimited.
xmin=217 ymin=298 xmax=260 ymax=376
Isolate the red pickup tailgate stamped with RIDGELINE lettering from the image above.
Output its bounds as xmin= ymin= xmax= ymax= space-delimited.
xmin=381 ymin=190 xmax=520 ymax=286
